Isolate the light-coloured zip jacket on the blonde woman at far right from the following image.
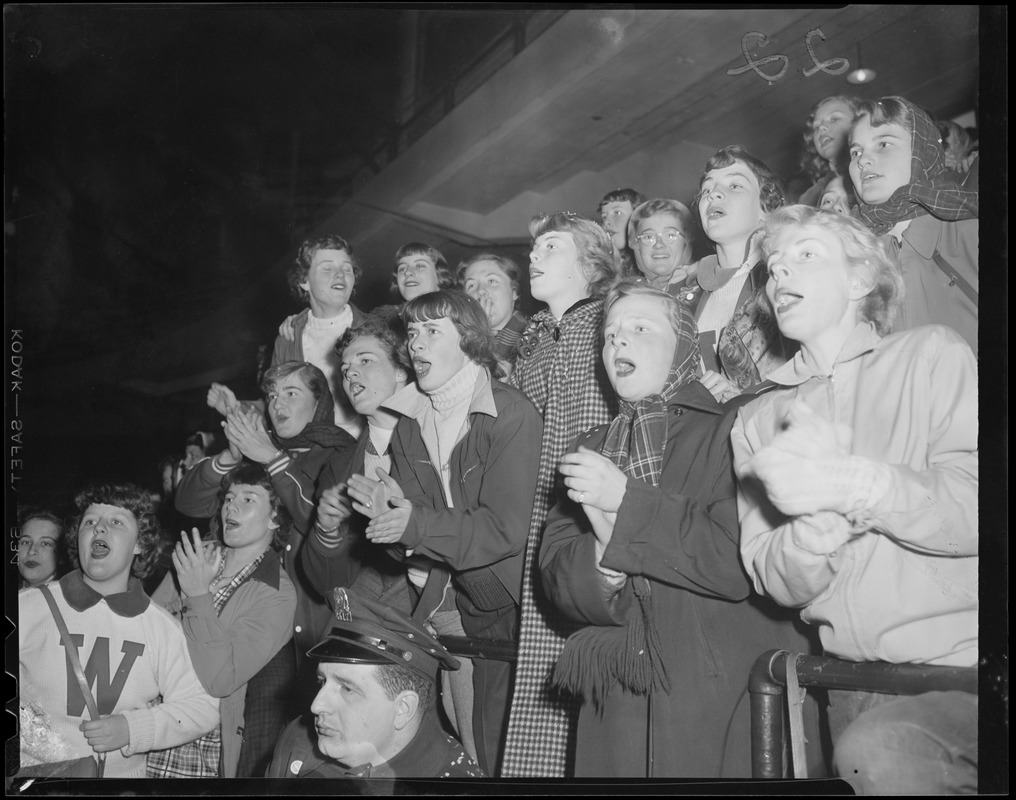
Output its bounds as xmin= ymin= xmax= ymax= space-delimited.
xmin=731 ymin=323 xmax=977 ymax=667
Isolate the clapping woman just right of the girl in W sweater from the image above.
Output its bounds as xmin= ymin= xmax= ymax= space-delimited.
xmin=148 ymin=461 xmax=296 ymax=778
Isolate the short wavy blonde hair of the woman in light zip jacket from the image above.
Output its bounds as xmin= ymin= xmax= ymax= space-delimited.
xmin=762 ymin=204 xmax=903 ymax=336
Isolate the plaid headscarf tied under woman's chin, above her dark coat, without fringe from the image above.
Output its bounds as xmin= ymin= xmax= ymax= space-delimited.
xmin=600 ymin=304 xmax=699 ymax=486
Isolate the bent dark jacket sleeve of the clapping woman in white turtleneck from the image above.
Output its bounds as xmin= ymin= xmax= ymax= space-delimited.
xmin=392 ymin=397 xmax=543 ymax=570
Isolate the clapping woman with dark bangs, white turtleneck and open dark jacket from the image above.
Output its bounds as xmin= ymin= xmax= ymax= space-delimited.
xmin=348 ymin=289 xmax=543 ymax=775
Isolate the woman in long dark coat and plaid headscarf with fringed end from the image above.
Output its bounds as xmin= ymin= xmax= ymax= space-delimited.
xmin=539 ymin=281 xmax=821 ymax=778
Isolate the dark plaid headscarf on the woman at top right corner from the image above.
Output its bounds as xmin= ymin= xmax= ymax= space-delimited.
xmin=858 ymin=97 xmax=977 ymax=236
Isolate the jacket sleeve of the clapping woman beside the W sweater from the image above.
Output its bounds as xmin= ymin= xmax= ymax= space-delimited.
xmin=183 ymin=577 xmax=297 ymax=697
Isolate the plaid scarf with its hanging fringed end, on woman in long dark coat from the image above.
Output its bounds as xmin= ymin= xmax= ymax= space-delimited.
xmin=553 ymin=307 xmax=699 ymax=712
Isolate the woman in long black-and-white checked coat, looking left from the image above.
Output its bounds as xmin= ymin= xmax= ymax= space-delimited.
xmin=501 ymin=211 xmax=617 ymax=778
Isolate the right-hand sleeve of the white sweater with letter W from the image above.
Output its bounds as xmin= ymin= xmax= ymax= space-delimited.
xmin=121 ymin=610 xmax=218 ymax=756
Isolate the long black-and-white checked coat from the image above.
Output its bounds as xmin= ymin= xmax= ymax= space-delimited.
xmin=501 ymin=299 xmax=615 ymax=778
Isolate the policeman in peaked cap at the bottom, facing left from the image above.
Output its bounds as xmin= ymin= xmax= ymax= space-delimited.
xmin=267 ymin=589 xmax=484 ymax=779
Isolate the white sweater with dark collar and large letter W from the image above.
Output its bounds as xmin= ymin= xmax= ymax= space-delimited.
xmin=17 ymin=570 xmax=218 ymax=778
